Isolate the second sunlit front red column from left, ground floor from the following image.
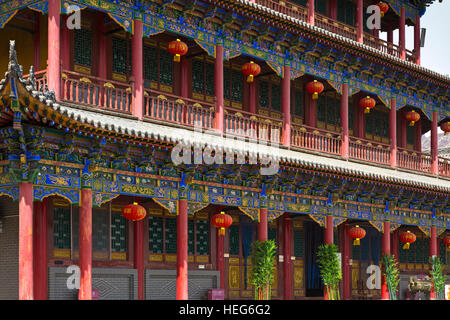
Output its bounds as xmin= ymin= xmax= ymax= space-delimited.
xmin=78 ymin=188 xmax=92 ymax=300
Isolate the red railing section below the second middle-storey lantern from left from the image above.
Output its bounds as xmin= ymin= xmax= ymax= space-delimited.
xmin=224 ymin=109 xmax=282 ymax=144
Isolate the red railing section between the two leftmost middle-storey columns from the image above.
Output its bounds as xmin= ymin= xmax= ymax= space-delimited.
xmin=61 ymin=71 xmax=132 ymax=113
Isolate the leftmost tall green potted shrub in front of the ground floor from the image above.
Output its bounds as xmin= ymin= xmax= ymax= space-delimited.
xmin=250 ymin=240 xmax=277 ymax=300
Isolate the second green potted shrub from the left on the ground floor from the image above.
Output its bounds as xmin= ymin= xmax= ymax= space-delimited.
xmin=317 ymin=244 xmax=342 ymax=300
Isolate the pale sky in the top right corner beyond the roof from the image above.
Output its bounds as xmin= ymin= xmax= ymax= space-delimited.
xmin=381 ymin=0 xmax=450 ymax=76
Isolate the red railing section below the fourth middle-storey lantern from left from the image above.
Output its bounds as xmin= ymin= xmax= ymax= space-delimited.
xmin=349 ymin=137 xmax=391 ymax=165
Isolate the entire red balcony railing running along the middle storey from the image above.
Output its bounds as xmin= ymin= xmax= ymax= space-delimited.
xmin=27 ymin=70 xmax=450 ymax=178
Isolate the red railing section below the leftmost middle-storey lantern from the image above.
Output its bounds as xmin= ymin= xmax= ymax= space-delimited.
xmin=144 ymin=91 xmax=215 ymax=129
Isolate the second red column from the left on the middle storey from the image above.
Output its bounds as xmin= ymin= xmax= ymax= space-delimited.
xmin=131 ymin=19 xmax=144 ymax=120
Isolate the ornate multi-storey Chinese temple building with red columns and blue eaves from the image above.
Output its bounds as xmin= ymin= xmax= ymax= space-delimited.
xmin=0 ymin=0 xmax=450 ymax=300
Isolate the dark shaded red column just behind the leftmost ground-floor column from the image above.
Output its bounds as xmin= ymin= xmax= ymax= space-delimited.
xmin=33 ymin=199 xmax=47 ymax=300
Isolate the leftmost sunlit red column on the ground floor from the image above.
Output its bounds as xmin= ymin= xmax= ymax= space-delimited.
xmin=19 ymin=182 xmax=34 ymax=300
